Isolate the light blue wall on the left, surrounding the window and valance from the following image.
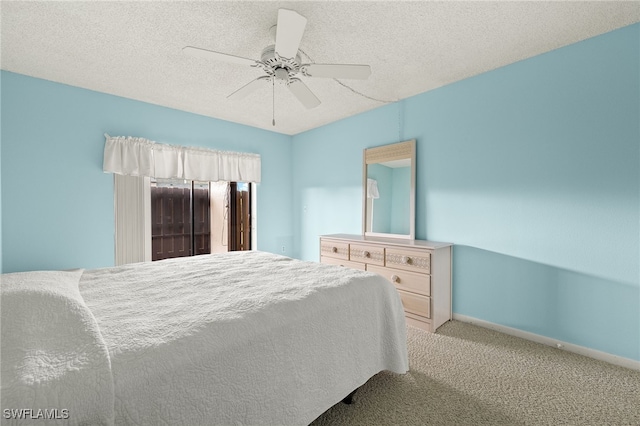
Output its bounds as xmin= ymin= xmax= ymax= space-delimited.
xmin=1 ymin=71 xmax=293 ymax=272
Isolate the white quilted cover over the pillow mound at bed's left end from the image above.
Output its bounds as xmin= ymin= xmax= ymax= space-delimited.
xmin=0 ymin=270 xmax=113 ymax=425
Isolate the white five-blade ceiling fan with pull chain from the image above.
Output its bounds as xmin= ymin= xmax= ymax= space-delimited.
xmin=182 ymin=9 xmax=371 ymax=115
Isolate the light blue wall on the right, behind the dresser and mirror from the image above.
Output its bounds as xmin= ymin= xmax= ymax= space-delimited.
xmin=293 ymin=25 xmax=640 ymax=360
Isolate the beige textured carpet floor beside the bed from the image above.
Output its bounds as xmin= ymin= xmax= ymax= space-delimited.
xmin=312 ymin=321 xmax=640 ymax=426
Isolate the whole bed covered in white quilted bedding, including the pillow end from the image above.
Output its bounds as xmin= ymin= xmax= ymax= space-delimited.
xmin=1 ymin=251 xmax=408 ymax=425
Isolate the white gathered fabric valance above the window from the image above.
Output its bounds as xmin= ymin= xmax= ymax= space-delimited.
xmin=103 ymin=134 xmax=260 ymax=183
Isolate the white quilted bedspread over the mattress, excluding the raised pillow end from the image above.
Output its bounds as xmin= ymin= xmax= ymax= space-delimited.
xmin=80 ymin=252 xmax=408 ymax=425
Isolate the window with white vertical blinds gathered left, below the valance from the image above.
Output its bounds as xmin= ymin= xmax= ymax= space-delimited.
xmin=114 ymin=174 xmax=256 ymax=265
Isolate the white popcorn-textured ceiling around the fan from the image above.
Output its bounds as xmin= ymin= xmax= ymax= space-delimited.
xmin=0 ymin=1 xmax=640 ymax=134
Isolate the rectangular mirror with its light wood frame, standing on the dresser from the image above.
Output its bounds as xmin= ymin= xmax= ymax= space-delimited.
xmin=362 ymin=139 xmax=416 ymax=239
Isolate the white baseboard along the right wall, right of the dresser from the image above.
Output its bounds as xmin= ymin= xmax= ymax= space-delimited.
xmin=453 ymin=314 xmax=640 ymax=370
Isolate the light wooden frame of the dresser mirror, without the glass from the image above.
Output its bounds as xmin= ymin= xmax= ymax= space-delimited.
xmin=362 ymin=139 xmax=416 ymax=240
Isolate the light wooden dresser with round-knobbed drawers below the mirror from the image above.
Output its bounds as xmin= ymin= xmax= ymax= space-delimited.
xmin=320 ymin=234 xmax=452 ymax=332
